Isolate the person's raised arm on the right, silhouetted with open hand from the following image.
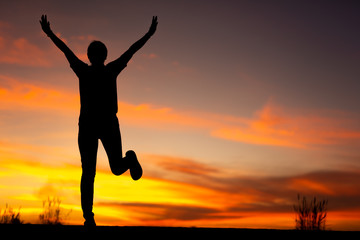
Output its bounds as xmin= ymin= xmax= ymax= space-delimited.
xmin=110 ymin=16 xmax=158 ymax=68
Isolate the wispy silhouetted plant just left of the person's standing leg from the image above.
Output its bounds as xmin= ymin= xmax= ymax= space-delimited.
xmin=39 ymin=197 xmax=71 ymax=225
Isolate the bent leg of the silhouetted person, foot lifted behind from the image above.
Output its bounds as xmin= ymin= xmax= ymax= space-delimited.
xmin=100 ymin=116 xmax=142 ymax=180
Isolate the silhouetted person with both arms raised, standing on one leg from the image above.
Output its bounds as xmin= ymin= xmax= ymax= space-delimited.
xmin=40 ymin=15 xmax=158 ymax=227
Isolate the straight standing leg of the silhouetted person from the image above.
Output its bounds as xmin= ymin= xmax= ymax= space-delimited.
xmin=78 ymin=124 xmax=98 ymax=223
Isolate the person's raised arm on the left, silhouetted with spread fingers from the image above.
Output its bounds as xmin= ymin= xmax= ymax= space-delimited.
xmin=40 ymin=15 xmax=82 ymax=65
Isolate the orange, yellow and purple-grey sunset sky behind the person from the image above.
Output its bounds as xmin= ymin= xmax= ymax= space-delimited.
xmin=0 ymin=0 xmax=360 ymax=230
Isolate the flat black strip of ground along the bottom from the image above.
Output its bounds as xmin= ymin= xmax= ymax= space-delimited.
xmin=0 ymin=224 xmax=360 ymax=240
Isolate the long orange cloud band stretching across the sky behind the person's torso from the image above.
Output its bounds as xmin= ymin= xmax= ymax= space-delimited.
xmin=0 ymin=75 xmax=360 ymax=148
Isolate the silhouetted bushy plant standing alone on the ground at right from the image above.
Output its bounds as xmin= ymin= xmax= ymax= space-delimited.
xmin=294 ymin=195 xmax=328 ymax=230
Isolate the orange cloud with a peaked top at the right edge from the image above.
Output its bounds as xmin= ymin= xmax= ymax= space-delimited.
xmin=212 ymin=103 xmax=360 ymax=148
